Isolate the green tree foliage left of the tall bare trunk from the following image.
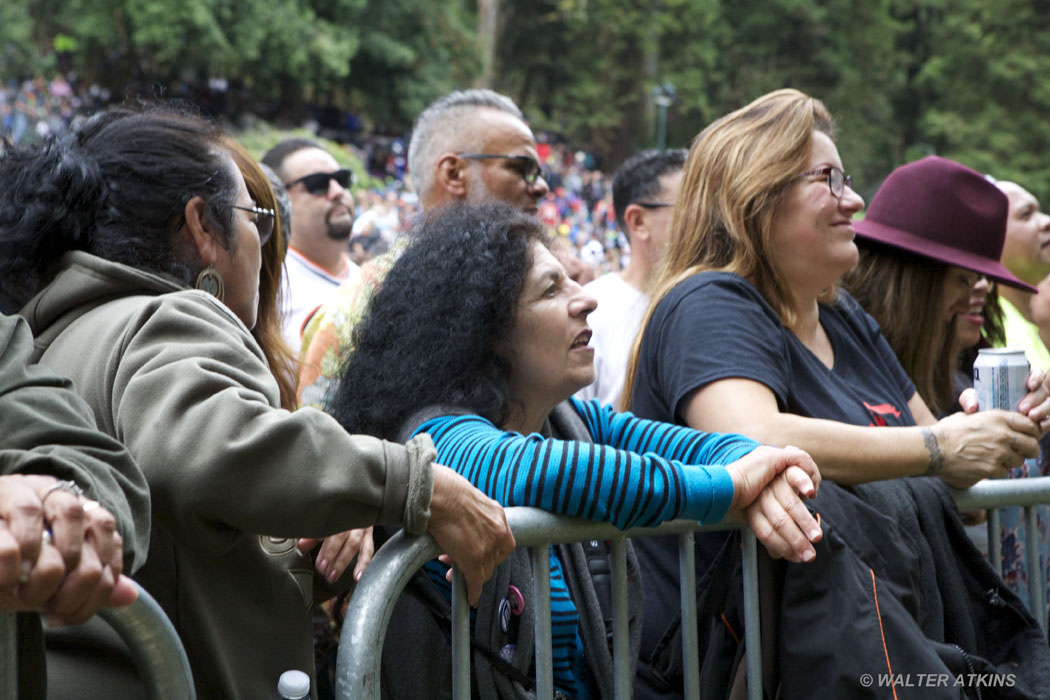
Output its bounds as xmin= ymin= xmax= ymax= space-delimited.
xmin=0 ymin=0 xmax=479 ymax=128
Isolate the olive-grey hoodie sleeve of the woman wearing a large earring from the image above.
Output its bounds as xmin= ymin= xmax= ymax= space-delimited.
xmin=94 ymin=292 xmax=434 ymax=552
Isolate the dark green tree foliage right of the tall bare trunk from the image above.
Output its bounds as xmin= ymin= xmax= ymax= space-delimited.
xmin=496 ymin=0 xmax=1050 ymax=197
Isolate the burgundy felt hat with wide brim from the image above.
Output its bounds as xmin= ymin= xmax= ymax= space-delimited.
xmin=854 ymin=155 xmax=1035 ymax=292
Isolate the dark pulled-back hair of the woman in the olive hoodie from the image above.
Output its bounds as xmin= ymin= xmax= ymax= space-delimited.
xmin=0 ymin=105 xmax=236 ymax=313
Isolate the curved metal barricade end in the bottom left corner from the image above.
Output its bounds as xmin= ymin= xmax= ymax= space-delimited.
xmin=0 ymin=584 xmax=196 ymax=700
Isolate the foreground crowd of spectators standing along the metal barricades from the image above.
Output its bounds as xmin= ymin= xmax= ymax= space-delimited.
xmin=0 ymin=83 xmax=1050 ymax=700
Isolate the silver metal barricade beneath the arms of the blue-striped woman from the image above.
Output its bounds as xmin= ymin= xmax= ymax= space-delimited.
xmin=336 ymin=508 xmax=761 ymax=700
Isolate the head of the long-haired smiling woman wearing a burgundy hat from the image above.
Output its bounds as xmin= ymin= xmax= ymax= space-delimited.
xmin=844 ymin=155 xmax=1034 ymax=416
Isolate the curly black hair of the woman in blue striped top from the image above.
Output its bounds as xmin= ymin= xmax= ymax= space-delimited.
xmin=328 ymin=204 xmax=547 ymax=440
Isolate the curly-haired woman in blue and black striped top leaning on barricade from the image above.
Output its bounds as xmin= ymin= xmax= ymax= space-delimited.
xmin=329 ymin=205 xmax=820 ymax=698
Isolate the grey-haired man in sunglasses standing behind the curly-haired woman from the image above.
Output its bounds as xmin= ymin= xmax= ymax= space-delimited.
xmin=299 ymin=89 xmax=548 ymax=404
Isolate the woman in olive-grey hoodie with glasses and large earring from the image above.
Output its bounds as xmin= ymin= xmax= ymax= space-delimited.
xmin=0 ymin=107 xmax=513 ymax=700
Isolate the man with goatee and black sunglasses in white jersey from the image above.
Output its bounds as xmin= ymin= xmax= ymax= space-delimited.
xmin=263 ymin=139 xmax=358 ymax=354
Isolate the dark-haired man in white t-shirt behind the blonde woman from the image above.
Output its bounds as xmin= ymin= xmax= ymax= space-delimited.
xmin=575 ymin=148 xmax=686 ymax=404
